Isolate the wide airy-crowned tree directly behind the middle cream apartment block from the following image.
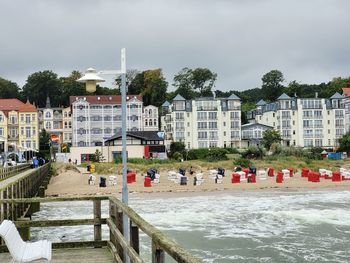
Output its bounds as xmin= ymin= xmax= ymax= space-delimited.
xmin=173 ymin=68 xmax=217 ymax=99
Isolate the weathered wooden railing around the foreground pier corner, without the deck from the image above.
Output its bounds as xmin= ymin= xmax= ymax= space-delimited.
xmin=0 ymin=196 xmax=201 ymax=263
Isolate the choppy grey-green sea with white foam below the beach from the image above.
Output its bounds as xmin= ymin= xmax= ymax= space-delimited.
xmin=32 ymin=190 xmax=350 ymax=263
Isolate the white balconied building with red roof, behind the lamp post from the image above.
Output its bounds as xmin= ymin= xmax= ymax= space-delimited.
xmin=70 ymin=95 xmax=143 ymax=147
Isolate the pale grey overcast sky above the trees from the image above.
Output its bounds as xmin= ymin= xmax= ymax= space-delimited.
xmin=0 ymin=0 xmax=350 ymax=90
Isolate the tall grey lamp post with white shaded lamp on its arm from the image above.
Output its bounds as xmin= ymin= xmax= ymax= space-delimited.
xmin=77 ymin=48 xmax=130 ymax=262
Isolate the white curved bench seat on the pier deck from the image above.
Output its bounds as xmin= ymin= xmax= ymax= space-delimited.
xmin=0 ymin=220 xmax=52 ymax=262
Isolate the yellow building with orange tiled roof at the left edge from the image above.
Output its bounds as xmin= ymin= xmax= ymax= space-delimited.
xmin=0 ymin=99 xmax=39 ymax=156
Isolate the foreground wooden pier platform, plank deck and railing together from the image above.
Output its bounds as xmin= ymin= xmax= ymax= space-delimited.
xmin=0 ymin=196 xmax=201 ymax=263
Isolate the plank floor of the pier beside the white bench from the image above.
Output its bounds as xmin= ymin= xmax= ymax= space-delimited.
xmin=0 ymin=247 xmax=114 ymax=263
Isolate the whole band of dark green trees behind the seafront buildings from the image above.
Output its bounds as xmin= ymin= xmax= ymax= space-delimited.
xmin=0 ymin=68 xmax=350 ymax=117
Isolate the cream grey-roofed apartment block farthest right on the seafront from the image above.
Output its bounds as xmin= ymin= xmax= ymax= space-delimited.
xmin=248 ymin=93 xmax=345 ymax=148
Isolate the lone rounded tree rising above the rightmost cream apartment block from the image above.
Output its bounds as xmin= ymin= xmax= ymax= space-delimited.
xmin=261 ymin=70 xmax=284 ymax=101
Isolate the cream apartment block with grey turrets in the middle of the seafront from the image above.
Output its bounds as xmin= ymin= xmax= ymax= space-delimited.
xmin=161 ymin=94 xmax=241 ymax=149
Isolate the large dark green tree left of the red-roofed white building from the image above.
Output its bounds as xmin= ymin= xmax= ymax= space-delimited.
xmin=22 ymin=70 xmax=62 ymax=107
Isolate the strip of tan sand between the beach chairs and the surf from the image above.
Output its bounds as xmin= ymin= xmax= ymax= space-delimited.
xmin=46 ymin=169 xmax=350 ymax=196
